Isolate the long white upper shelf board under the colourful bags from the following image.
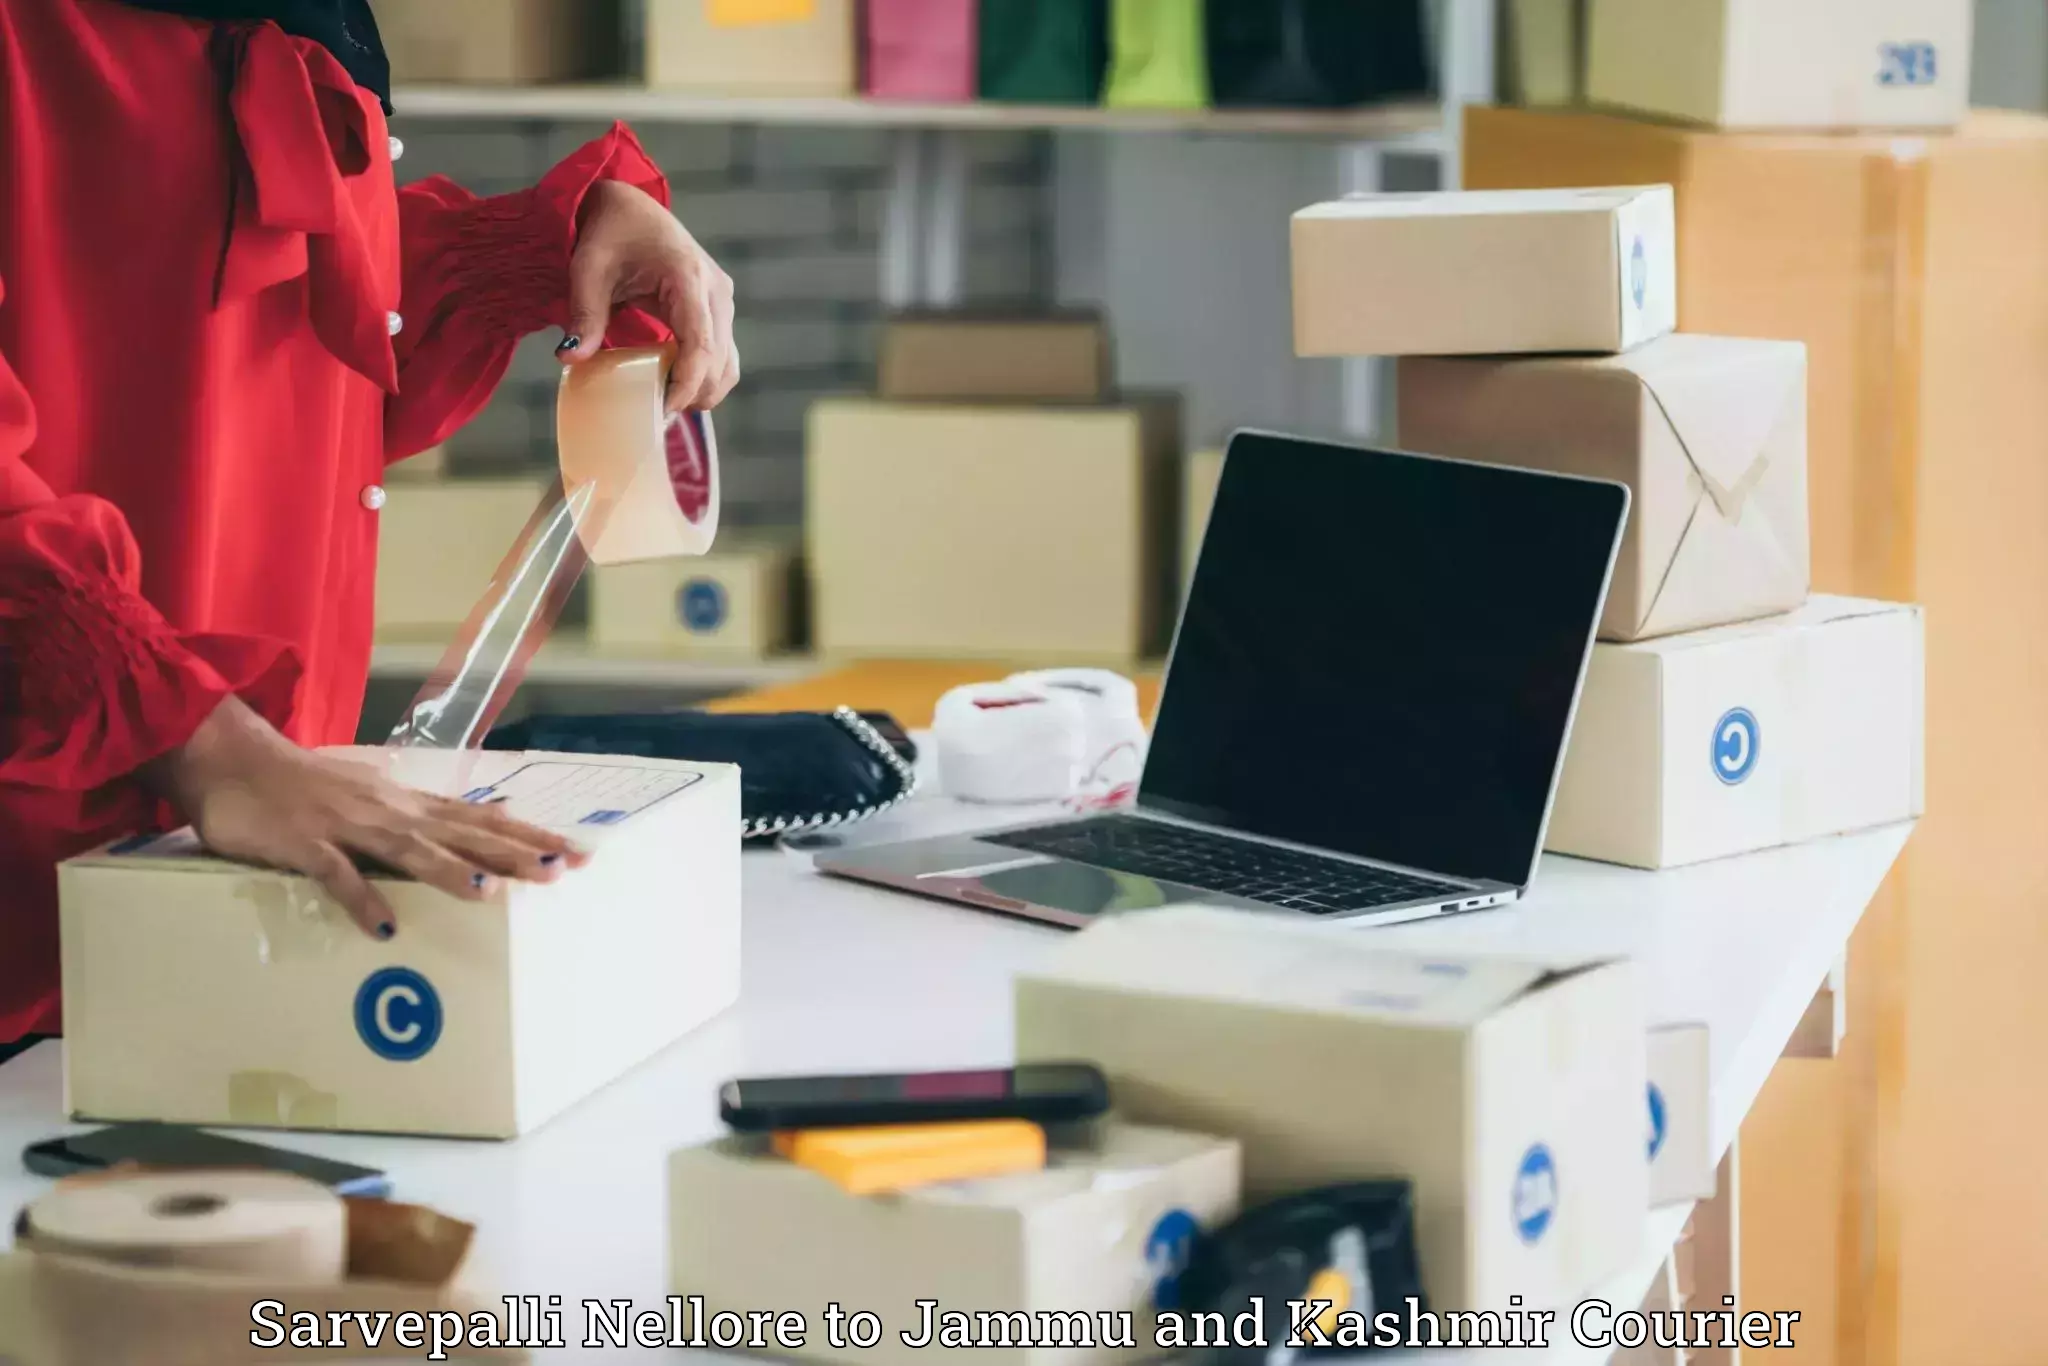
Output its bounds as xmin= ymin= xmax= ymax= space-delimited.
xmin=391 ymin=84 xmax=1444 ymax=141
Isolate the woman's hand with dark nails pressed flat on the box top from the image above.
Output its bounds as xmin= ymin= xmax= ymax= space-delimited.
xmin=143 ymin=698 xmax=588 ymax=940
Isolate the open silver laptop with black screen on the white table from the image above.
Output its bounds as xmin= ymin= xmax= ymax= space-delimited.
xmin=817 ymin=432 xmax=1628 ymax=928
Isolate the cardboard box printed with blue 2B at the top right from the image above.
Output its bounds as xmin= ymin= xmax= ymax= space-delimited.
xmin=1585 ymin=0 xmax=1976 ymax=131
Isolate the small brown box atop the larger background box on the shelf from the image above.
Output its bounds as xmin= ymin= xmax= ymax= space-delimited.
xmin=881 ymin=315 xmax=1114 ymax=403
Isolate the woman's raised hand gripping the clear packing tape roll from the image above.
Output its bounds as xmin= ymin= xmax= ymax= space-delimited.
xmin=555 ymin=180 xmax=739 ymax=412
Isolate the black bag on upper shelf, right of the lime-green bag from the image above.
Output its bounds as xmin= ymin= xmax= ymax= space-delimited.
xmin=1204 ymin=0 xmax=1430 ymax=109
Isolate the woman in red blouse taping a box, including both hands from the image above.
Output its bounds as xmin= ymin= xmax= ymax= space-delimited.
xmin=0 ymin=0 xmax=739 ymax=1053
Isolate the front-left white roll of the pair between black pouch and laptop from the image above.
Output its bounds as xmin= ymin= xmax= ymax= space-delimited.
xmin=932 ymin=682 xmax=1087 ymax=805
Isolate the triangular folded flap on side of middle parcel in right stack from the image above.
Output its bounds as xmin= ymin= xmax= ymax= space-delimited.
xmin=1638 ymin=338 xmax=1804 ymax=522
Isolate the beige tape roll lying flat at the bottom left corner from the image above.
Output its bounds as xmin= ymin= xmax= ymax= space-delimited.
xmin=23 ymin=1171 xmax=348 ymax=1284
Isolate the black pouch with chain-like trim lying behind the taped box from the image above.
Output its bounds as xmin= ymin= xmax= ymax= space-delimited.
xmin=483 ymin=707 xmax=918 ymax=840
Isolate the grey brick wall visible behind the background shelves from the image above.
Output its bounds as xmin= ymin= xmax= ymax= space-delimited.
xmin=393 ymin=117 xmax=1053 ymax=524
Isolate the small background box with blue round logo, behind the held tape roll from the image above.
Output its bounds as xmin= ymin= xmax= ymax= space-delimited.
xmin=590 ymin=537 xmax=797 ymax=659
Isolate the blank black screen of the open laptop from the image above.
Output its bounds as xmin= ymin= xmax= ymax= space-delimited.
xmin=1139 ymin=434 xmax=1628 ymax=887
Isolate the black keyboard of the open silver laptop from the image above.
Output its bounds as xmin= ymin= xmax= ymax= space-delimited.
xmin=979 ymin=815 xmax=1468 ymax=915
